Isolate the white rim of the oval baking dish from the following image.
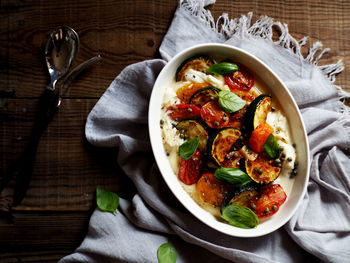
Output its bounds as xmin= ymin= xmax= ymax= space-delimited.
xmin=148 ymin=43 xmax=310 ymax=238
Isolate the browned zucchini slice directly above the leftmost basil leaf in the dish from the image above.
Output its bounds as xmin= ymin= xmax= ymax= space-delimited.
xmin=176 ymin=120 xmax=209 ymax=153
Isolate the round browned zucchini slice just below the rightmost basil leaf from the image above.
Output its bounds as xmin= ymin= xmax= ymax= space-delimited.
xmin=241 ymin=156 xmax=281 ymax=184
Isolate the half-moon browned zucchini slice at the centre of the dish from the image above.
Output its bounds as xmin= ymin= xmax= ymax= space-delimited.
xmin=208 ymin=128 xmax=241 ymax=166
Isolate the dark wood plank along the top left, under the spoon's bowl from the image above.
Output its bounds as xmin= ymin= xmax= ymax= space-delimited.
xmin=0 ymin=0 xmax=176 ymax=98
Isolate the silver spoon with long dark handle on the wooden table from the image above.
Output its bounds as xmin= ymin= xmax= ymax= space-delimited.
xmin=0 ymin=26 xmax=79 ymax=206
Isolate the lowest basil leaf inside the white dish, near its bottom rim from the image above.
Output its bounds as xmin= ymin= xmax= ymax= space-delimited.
xmin=221 ymin=205 xmax=259 ymax=228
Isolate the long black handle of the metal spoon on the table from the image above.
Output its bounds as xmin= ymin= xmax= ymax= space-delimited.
xmin=12 ymin=89 xmax=58 ymax=206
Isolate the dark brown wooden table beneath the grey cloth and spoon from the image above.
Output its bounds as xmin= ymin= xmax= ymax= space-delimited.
xmin=0 ymin=0 xmax=350 ymax=262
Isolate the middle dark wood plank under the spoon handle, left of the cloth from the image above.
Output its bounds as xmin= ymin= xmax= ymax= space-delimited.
xmin=0 ymin=99 xmax=132 ymax=210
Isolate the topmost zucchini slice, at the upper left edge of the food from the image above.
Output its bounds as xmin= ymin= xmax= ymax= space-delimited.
xmin=176 ymin=55 xmax=214 ymax=81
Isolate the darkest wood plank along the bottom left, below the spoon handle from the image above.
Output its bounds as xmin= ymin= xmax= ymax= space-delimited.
xmin=0 ymin=211 xmax=91 ymax=262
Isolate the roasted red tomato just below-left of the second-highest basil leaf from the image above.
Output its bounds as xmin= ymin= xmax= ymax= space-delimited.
xmin=201 ymin=101 xmax=230 ymax=129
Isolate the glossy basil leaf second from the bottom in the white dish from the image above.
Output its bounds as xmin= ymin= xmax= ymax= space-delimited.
xmin=214 ymin=167 xmax=251 ymax=186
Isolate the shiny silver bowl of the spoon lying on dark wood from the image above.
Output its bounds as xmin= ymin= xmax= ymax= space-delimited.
xmin=45 ymin=26 xmax=79 ymax=90
